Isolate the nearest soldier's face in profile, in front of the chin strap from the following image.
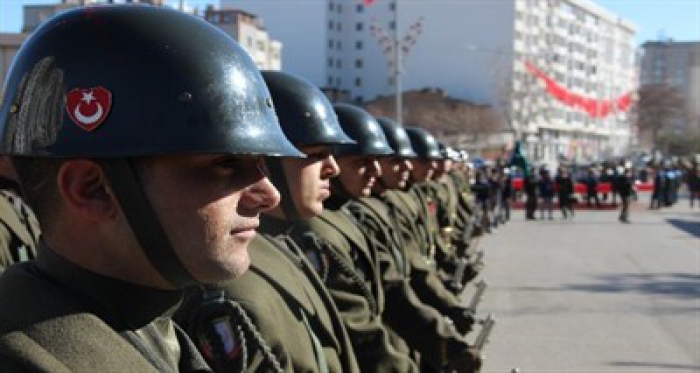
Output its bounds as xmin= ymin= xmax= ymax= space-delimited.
xmin=144 ymin=155 xmax=279 ymax=283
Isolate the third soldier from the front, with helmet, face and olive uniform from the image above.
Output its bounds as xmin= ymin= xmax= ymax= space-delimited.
xmin=301 ymin=104 xmax=418 ymax=372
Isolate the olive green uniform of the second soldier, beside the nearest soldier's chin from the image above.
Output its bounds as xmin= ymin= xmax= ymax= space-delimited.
xmin=187 ymin=230 xmax=359 ymax=372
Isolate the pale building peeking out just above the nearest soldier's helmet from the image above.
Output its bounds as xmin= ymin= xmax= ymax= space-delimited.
xmin=204 ymin=5 xmax=282 ymax=70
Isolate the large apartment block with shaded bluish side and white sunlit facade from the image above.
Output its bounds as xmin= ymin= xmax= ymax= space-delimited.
xmin=232 ymin=0 xmax=638 ymax=163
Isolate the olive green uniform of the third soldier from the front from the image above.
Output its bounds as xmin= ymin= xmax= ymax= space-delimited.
xmin=302 ymin=201 xmax=418 ymax=372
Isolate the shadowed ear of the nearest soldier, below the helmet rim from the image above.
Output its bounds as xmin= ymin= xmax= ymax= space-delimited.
xmin=57 ymin=159 xmax=119 ymax=222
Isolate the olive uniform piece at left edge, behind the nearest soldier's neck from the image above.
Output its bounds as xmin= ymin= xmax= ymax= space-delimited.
xmin=0 ymin=155 xmax=41 ymax=272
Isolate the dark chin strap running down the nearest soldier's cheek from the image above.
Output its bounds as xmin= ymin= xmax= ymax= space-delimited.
xmin=98 ymin=158 xmax=197 ymax=288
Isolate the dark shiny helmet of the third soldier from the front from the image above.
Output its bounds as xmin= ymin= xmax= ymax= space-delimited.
xmin=333 ymin=104 xmax=394 ymax=156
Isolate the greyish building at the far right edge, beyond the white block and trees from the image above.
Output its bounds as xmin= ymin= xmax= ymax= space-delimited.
xmin=640 ymin=40 xmax=700 ymax=142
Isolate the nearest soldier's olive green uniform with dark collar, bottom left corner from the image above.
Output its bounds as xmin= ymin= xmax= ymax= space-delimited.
xmin=0 ymin=247 xmax=211 ymax=373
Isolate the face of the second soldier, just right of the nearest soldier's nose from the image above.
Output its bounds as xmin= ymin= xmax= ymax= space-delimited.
xmin=282 ymin=145 xmax=340 ymax=218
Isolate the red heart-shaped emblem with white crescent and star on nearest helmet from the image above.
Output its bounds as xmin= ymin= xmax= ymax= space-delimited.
xmin=66 ymin=86 xmax=112 ymax=132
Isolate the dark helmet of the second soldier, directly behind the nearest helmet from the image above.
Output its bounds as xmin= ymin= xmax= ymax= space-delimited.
xmin=262 ymin=71 xmax=355 ymax=146
